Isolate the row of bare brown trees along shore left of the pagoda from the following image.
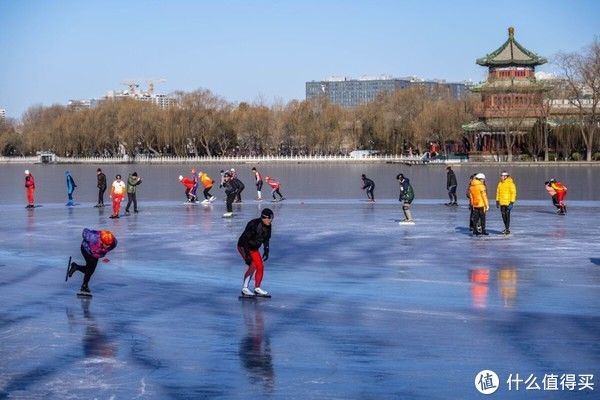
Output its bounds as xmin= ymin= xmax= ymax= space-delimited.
xmin=0 ymin=88 xmax=476 ymax=157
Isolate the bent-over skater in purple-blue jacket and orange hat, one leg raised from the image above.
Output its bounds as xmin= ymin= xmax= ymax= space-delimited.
xmin=68 ymin=228 xmax=117 ymax=296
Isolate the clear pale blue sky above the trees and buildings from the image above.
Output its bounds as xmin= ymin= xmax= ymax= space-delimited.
xmin=0 ymin=0 xmax=600 ymax=118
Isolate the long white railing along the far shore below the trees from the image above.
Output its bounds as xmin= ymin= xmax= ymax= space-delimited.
xmin=0 ymin=155 xmax=468 ymax=164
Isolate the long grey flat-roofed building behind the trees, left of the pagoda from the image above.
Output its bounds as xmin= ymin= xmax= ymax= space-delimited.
xmin=306 ymin=76 xmax=467 ymax=107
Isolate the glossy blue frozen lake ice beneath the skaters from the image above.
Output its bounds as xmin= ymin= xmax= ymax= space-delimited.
xmin=0 ymin=199 xmax=600 ymax=399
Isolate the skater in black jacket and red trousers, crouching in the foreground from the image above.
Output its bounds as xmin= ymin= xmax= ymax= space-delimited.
xmin=238 ymin=208 xmax=273 ymax=297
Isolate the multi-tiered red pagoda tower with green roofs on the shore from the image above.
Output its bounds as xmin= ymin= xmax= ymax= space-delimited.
xmin=463 ymin=27 xmax=547 ymax=161
